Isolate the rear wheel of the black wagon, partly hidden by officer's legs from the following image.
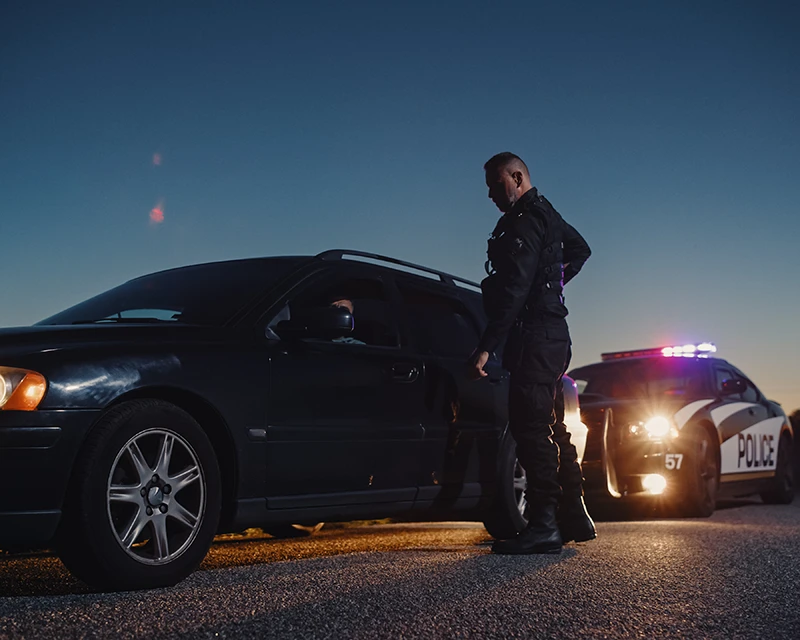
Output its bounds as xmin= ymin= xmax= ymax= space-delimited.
xmin=483 ymin=434 xmax=528 ymax=540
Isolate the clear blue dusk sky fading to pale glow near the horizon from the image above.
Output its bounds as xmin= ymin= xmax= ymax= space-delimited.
xmin=0 ymin=0 xmax=800 ymax=411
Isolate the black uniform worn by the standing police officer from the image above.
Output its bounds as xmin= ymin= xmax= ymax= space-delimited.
xmin=478 ymin=188 xmax=591 ymax=505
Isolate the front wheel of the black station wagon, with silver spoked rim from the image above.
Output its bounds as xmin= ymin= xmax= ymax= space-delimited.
xmin=56 ymin=399 xmax=222 ymax=590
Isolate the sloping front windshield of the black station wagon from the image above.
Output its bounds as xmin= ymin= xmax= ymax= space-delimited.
xmin=36 ymin=258 xmax=301 ymax=326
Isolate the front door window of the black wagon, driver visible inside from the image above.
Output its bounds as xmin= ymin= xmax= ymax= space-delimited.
xmin=270 ymin=275 xmax=400 ymax=348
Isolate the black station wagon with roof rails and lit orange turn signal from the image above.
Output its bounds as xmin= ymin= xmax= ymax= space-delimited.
xmin=0 ymin=250 xmax=583 ymax=588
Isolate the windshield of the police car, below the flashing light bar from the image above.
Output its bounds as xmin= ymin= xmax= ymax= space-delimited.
xmin=569 ymin=358 xmax=703 ymax=399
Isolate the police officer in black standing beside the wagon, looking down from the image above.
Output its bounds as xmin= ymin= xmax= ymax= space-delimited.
xmin=470 ymin=152 xmax=596 ymax=554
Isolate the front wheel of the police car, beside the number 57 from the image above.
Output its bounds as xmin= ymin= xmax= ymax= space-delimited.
xmin=682 ymin=426 xmax=719 ymax=518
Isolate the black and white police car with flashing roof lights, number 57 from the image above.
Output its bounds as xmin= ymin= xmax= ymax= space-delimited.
xmin=568 ymin=343 xmax=794 ymax=517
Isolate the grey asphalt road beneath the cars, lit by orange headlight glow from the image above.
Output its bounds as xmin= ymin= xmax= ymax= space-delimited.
xmin=0 ymin=499 xmax=800 ymax=639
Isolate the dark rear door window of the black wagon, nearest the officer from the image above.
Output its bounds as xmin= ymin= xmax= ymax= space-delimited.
xmin=397 ymin=282 xmax=480 ymax=359
